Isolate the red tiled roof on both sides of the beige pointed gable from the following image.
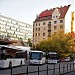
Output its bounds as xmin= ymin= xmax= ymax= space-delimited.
xmin=35 ymin=5 xmax=70 ymax=22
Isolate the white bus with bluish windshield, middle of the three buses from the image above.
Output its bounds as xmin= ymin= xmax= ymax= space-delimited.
xmin=29 ymin=51 xmax=46 ymax=64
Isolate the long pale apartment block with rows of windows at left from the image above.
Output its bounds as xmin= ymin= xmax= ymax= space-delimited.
xmin=0 ymin=14 xmax=33 ymax=42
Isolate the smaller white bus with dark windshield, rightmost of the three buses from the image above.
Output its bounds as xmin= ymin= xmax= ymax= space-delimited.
xmin=47 ymin=52 xmax=58 ymax=63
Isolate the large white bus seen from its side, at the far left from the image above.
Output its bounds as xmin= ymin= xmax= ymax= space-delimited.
xmin=0 ymin=45 xmax=30 ymax=68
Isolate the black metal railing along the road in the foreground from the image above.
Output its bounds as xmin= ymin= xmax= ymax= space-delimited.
xmin=10 ymin=63 xmax=75 ymax=75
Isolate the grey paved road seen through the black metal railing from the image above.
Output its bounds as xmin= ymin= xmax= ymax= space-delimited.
xmin=0 ymin=62 xmax=75 ymax=75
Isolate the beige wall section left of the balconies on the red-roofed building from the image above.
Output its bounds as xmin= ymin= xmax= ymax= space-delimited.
xmin=33 ymin=21 xmax=48 ymax=43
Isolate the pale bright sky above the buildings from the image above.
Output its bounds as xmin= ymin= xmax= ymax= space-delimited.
xmin=0 ymin=0 xmax=75 ymax=25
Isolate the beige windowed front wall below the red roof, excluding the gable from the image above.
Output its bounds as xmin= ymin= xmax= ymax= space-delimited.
xmin=33 ymin=19 xmax=64 ymax=44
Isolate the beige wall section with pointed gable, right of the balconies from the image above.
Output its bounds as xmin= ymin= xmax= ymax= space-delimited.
xmin=51 ymin=8 xmax=64 ymax=35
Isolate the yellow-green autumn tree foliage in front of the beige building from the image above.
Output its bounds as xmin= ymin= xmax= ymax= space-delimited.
xmin=36 ymin=31 xmax=75 ymax=57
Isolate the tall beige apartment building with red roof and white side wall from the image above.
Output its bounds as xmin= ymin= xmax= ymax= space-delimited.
xmin=33 ymin=5 xmax=71 ymax=44
